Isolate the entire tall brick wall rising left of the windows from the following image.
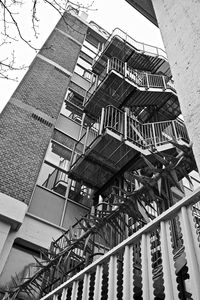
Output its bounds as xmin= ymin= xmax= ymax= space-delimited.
xmin=0 ymin=12 xmax=86 ymax=203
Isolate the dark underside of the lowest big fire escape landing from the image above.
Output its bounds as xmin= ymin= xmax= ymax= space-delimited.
xmin=69 ymin=133 xmax=136 ymax=189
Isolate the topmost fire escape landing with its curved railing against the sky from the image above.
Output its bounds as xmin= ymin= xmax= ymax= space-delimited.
xmin=93 ymin=28 xmax=171 ymax=77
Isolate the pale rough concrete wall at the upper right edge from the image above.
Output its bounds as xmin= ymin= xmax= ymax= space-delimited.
xmin=152 ymin=0 xmax=200 ymax=170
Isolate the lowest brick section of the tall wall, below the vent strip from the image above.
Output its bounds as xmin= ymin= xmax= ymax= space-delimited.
xmin=0 ymin=103 xmax=51 ymax=202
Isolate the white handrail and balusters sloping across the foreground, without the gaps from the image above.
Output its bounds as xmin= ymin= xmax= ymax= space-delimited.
xmin=41 ymin=189 xmax=200 ymax=300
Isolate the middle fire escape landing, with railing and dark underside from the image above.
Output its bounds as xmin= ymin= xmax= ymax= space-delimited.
xmin=84 ymin=57 xmax=181 ymax=122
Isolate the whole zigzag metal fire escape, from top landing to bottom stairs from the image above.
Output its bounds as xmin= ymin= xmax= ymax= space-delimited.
xmin=5 ymin=29 xmax=196 ymax=299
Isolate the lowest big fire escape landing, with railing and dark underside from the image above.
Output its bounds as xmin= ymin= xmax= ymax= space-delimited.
xmin=69 ymin=106 xmax=189 ymax=189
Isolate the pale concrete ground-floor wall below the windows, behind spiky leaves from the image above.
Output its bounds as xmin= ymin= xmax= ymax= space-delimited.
xmin=0 ymin=215 xmax=62 ymax=288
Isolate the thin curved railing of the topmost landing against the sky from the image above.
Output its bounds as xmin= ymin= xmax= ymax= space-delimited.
xmin=94 ymin=28 xmax=167 ymax=62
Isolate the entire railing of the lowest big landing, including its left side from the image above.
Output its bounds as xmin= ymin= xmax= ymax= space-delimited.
xmin=71 ymin=105 xmax=189 ymax=170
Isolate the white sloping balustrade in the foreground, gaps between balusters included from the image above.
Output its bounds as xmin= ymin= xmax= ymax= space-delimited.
xmin=41 ymin=189 xmax=200 ymax=300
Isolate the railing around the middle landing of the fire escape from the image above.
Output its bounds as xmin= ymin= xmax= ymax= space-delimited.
xmin=84 ymin=57 xmax=176 ymax=105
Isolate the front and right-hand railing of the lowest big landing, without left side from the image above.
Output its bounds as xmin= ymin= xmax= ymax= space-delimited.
xmin=103 ymin=105 xmax=189 ymax=149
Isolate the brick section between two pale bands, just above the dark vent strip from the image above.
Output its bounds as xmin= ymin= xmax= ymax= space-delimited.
xmin=13 ymin=57 xmax=71 ymax=118
